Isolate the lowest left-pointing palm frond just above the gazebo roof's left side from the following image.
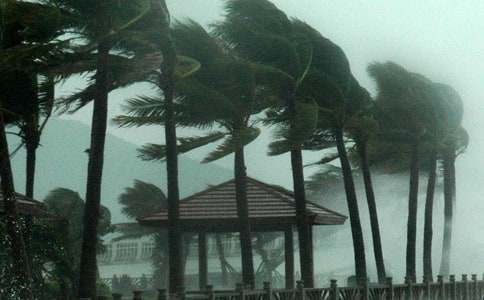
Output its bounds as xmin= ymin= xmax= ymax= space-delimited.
xmin=138 ymin=132 xmax=227 ymax=161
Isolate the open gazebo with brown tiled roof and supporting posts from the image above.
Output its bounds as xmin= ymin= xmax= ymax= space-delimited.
xmin=138 ymin=177 xmax=347 ymax=289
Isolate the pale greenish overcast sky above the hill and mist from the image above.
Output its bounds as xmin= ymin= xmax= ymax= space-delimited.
xmin=59 ymin=0 xmax=484 ymax=185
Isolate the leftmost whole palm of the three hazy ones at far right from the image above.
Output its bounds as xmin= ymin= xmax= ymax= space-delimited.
xmin=368 ymin=62 xmax=444 ymax=281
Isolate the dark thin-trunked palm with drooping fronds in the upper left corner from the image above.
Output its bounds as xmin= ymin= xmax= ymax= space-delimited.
xmin=2 ymin=1 xmax=64 ymax=198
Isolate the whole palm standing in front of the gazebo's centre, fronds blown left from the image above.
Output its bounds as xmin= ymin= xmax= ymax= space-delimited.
xmin=116 ymin=21 xmax=276 ymax=286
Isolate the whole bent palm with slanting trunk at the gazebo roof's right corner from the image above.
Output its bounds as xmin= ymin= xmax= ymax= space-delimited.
xmin=286 ymin=20 xmax=368 ymax=283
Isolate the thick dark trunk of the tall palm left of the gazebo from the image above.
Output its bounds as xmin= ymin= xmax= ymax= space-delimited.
xmin=78 ymin=5 xmax=110 ymax=299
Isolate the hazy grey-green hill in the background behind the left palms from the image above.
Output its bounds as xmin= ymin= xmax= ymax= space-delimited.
xmin=9 ymin=119 xmax=233 ymax=223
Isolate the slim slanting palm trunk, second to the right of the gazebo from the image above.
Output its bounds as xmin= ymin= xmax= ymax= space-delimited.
xmin=357 ymin=141 xmax=386 ymax=283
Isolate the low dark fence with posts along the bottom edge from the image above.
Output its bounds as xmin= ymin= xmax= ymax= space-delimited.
xmin=99 ymin=275 xmax=484 ymax=300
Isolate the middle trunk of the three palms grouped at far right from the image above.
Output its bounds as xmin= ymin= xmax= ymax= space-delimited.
xmin=423 ymin=150 xmax=437 ymax=281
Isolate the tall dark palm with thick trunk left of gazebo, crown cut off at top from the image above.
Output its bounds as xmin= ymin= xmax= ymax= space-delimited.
xmin=37 ymin=0 xmax=155 ymax=298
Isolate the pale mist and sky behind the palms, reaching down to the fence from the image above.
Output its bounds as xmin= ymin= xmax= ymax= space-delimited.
xmin=27 ymin=0 xmax=484 ymax=292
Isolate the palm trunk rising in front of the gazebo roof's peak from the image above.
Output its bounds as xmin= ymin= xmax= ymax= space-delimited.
xmin=234 ymin=129 xmax=255 ymax=288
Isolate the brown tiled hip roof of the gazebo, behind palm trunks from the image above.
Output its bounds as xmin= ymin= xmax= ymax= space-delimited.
xmin=138 ymin=177 xmax=347 ymax=230
